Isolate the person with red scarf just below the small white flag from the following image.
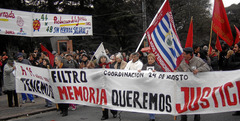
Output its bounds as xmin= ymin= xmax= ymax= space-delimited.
xmin=96 ymin=54 xmax=117 ymax=120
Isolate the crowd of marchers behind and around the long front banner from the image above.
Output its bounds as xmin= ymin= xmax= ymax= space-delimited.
xmin=0 ymin=43 xmax=240 ymax=121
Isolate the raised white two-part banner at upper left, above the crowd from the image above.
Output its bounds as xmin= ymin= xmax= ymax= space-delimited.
xmin=0 ymin=8 xmax=93 ymax=37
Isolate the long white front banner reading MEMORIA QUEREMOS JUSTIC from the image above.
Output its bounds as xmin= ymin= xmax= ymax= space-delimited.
xmin=16 ymin=63 xmax=240 ymax=115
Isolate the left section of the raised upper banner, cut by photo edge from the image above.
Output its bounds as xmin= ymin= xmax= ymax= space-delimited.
xmin=0 ymin=8 xmax=33 ymax=36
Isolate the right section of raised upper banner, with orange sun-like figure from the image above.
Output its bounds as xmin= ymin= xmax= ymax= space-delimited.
xmin=32 ymin=13 xmax=93 ymax=36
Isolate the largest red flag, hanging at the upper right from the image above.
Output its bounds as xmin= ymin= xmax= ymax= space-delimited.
xmin=212 ymin=0 xmax=233 ymax=46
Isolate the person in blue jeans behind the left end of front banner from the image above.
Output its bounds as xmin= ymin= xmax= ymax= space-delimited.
xmin=17 ymin=53 xmax=35 ymax=104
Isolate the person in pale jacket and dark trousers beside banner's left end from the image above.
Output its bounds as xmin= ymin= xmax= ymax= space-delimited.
xmin=3 ymin=59 xmax=18 ymax=107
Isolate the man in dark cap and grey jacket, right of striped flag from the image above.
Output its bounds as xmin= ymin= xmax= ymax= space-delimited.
xmin=177 ymin=47 xmax=210 ymax=121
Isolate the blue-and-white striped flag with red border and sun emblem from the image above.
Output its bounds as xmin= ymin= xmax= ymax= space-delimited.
xmin=146 ymin=0 xmax=183 ymax=72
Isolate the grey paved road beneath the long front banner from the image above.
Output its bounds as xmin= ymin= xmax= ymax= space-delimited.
xmin=9 ymin=106 xmax=240 ymax=121
